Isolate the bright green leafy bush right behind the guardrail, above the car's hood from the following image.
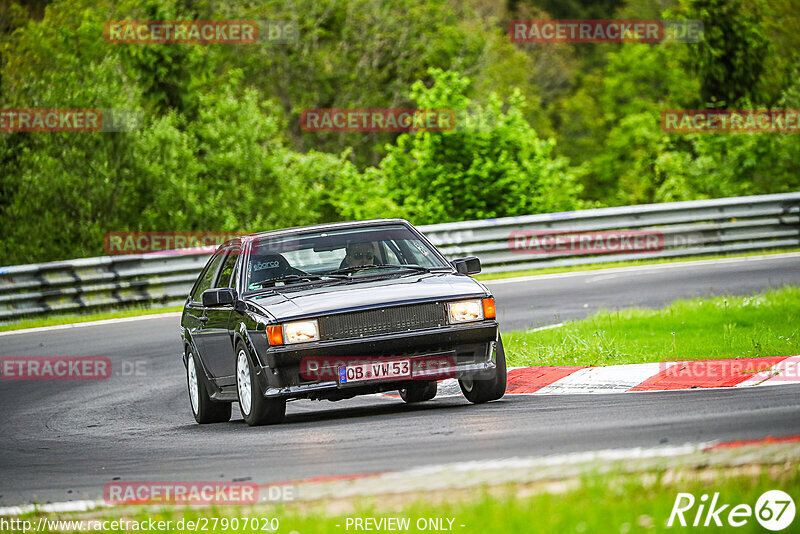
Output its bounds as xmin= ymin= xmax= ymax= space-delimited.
xmin=375 ymin=69 xmax=579 ymax=223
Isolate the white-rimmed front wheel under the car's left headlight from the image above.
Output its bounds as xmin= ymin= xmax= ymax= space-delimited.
xmin=236 ymin=343 xmax=286 ymax=426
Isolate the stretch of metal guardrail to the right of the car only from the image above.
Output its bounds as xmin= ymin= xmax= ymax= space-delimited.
xmin=420 ymin=193 xmax=800 ymax=272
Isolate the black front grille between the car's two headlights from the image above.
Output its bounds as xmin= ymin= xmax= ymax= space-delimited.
xmin=319 ymin=302 xmax=446 ymax=340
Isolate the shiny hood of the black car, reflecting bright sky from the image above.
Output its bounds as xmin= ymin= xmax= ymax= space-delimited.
xmin=248 ymin=273 xmax=488 ymax=320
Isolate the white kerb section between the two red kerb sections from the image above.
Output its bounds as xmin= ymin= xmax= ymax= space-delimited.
xmin=536 ymin=362 xmax=676 ymax=395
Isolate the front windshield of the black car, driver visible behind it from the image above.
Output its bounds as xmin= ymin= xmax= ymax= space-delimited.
xmin=246 ymin=224 xmax=450 ymax=291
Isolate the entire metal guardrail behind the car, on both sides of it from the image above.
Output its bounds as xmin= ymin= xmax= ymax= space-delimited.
xmin=0 ymin=192 xmax=800 ymax=321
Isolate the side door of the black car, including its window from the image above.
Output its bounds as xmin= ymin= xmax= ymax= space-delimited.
xmin=202 ymin=246 xmax=241 ymax=385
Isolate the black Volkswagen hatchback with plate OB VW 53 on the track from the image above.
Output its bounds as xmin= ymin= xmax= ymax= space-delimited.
xmin=181 ymin=219 xmax=506 ymax=425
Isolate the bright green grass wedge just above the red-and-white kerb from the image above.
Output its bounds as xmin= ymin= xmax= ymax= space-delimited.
xmin=503 ymin=286 xmax=800 ymax=366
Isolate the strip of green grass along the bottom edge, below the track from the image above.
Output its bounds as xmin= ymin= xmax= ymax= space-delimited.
xmin=9 ymin=464 xmax=800 ymax=534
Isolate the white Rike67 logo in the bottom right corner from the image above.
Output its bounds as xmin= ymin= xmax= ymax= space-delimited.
xmin=667 ymin=490 xmax=796 ymax=532
